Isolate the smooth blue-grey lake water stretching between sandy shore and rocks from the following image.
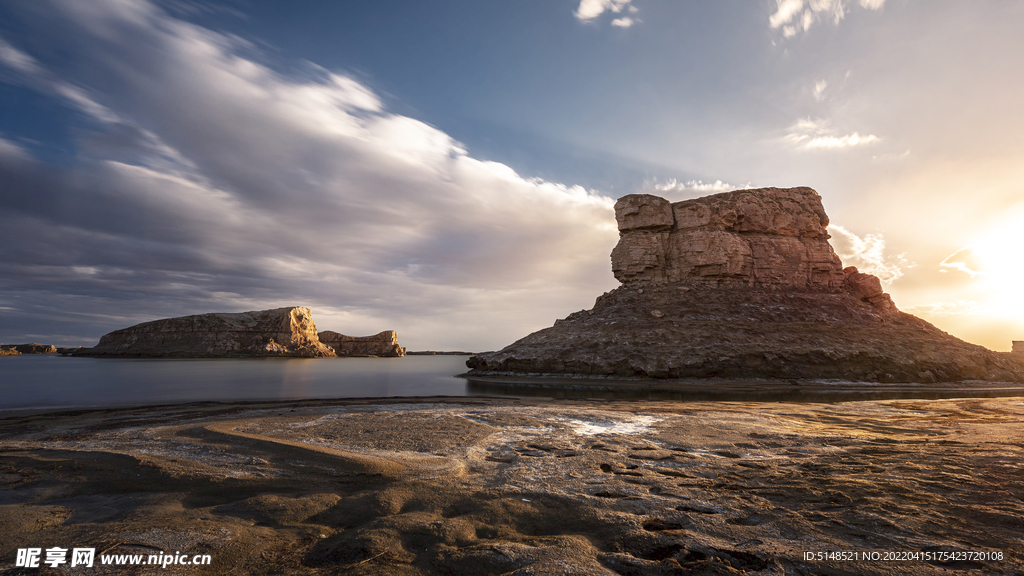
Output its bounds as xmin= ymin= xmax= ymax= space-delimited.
xmin=0 ymin=355 xmax=1024 ymax=410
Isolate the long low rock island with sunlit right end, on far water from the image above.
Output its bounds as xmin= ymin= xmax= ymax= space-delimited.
xmin=80 ymin=307 xmax=335 ymax=358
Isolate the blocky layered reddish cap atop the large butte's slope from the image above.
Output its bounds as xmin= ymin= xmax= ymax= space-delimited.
xmin=611 ymin=188 xmax=845 ymax=291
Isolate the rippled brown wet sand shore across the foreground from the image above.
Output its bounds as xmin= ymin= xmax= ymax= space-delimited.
xmin=0 ymin=398 xmax=1024 ymax=575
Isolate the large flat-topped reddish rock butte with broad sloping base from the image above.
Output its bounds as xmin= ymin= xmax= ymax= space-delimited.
xmin=467 ymin=188 xmax=1024 ymax=382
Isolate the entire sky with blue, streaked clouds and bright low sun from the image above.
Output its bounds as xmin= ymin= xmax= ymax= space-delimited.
xmin=0 ymin=0 xmax=1024 ymax=352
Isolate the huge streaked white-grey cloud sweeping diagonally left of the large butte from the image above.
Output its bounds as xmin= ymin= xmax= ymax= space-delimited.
xmin=0 ymin=0 xmax=627 ymax=349
